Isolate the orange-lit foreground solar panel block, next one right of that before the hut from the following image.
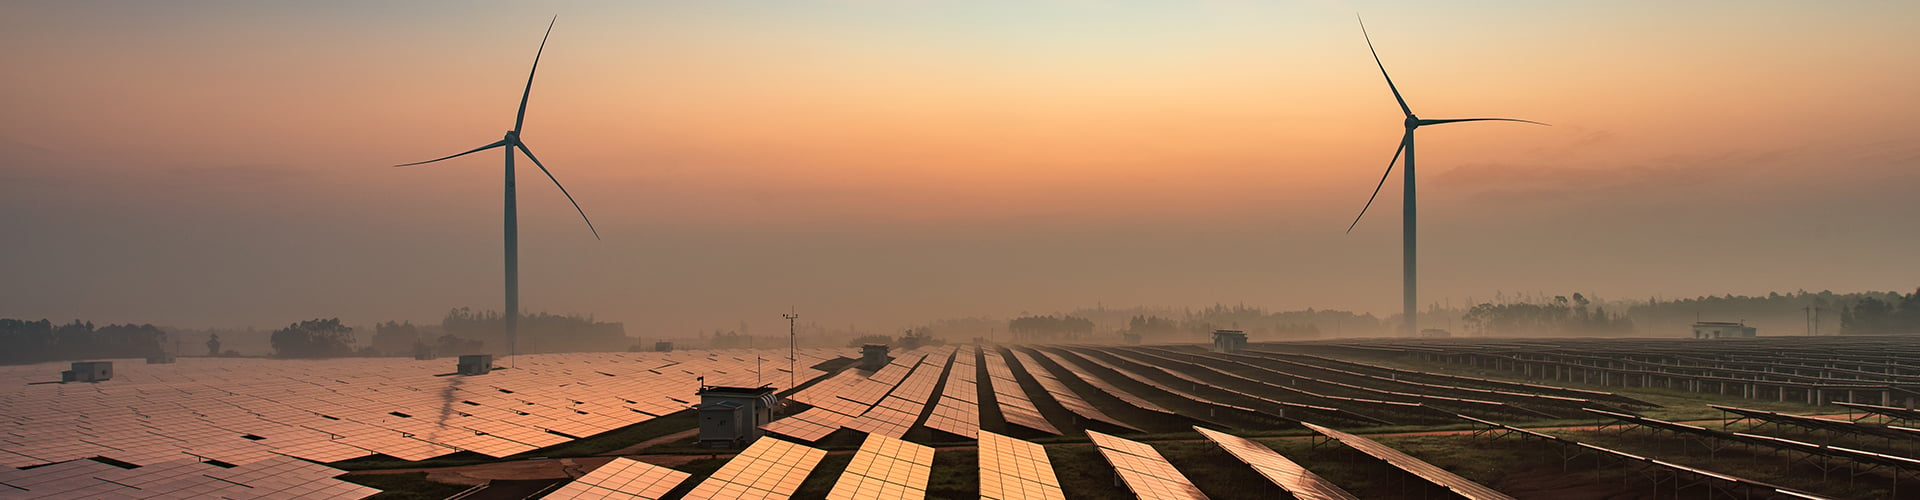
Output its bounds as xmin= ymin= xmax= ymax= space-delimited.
xmin=828 ymin=435 xmax=933 ymax=500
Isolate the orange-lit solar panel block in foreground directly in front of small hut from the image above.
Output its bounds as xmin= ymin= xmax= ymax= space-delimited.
xmin=685 ymin=437 xmax=828 ymax=498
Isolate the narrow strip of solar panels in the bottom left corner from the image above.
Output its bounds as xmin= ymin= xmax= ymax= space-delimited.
xmin=0 ymin=456 xmax=380 ymax=498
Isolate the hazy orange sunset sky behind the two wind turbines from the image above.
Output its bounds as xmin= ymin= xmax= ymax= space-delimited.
xmin=0 ymin=0 xmax=1920 ymax=337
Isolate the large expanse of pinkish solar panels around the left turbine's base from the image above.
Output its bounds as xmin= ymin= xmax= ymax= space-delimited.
xmin=0 ymin=348 xmax=856 ymax=467
